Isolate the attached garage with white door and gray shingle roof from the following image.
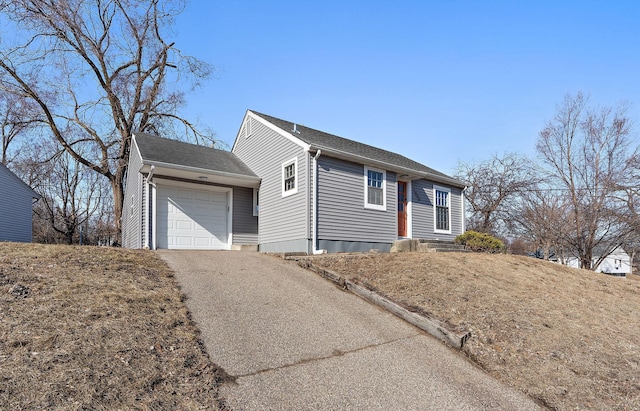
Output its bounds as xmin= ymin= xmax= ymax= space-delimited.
xmin=122 ymin=133 xmax=261 ymax=250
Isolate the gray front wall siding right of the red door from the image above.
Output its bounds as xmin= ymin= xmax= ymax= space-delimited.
xmin=411 ymin=180 xmax=463 ymax=241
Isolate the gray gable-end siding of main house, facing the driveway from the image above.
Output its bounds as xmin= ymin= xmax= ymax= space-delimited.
xmin=233 ymin=120 xmax=309 ymax=251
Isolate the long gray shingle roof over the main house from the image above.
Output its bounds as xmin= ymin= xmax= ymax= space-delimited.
xmin=250 ymin=110 xmax=464 ymax=187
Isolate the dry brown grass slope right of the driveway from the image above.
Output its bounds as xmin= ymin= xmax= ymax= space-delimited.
xmin=302 ymin=253 xmax=640 ymax=410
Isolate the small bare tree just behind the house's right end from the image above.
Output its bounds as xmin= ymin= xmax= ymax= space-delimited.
xmin=455 ymin=153 xmax=536 ymax=235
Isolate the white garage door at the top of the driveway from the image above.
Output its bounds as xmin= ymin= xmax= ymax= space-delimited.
xmin=156 ymin=185 xmax=230 ymax=250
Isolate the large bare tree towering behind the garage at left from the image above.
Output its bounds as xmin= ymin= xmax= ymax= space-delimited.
xmin=0 ymin=0 xmax=212 ymax=240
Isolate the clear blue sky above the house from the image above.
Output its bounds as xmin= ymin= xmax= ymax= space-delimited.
xmin=175 ymin=0 xmax=640 ymax=173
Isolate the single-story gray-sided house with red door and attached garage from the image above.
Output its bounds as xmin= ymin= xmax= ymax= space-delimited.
xmin=122 ymin=110 xmax=465 ymax=254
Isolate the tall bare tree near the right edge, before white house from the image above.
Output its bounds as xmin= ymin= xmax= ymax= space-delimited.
xmin=536 ymin=93 xmax=638 ymax=269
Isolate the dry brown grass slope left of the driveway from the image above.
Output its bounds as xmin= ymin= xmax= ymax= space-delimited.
xmin=0 ymin=243 xmax=230 ymax=410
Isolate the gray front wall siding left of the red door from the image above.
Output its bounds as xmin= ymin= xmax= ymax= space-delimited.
xmin=318 ymin=156 xmax=398 ymax=248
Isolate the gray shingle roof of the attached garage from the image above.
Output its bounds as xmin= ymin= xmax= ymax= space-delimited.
xmin=134 ymin=133 xmax=257 ymax=177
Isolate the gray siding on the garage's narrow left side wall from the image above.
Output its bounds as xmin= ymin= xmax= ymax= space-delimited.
xmin=122 ymin=144 xmax=145 ymax=248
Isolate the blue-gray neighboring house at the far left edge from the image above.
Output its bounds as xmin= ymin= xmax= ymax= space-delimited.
xmin=0 ymin=163 xmax=40 ymax=243
